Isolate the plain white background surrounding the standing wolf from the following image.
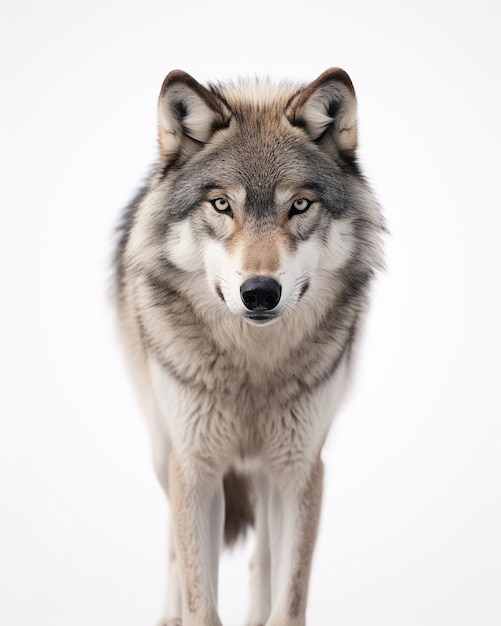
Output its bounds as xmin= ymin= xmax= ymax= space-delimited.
xmin=0 ymin=0 xmax=501 ymax=626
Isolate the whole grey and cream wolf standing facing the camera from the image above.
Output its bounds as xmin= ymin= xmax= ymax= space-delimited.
xmin=115 ymin=68 xmax=385 ymax=626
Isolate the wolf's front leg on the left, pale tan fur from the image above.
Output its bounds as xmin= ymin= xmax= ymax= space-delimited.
xmin=169 ymin=450 xmax=224 ymax=626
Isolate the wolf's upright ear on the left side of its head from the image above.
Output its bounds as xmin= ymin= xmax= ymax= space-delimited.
xmin=158 ymin=70 xmax=231 ymax=165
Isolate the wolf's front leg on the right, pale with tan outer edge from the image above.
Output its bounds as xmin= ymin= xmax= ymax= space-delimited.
xmin=266 ymin=459 xmax=323 ymax=626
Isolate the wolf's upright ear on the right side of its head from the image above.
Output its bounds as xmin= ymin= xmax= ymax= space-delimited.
xmin=285 ymin=67 xmax=357 ymax=155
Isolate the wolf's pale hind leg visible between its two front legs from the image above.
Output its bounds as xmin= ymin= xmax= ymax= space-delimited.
xmin=247 ymin=473 xmax=271 ymax=626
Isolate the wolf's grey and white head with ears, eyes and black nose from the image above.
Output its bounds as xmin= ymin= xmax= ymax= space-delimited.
xmin=122 ymin=68 xmax=381 ymax=325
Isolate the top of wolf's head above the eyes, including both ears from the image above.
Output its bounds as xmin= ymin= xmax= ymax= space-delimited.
xmin=159 ymin=70 xmax=359 ymax=218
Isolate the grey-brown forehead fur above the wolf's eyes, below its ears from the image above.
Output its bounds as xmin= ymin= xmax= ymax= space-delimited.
xmin=156 ymin=105 xmax=361 ymax=232
